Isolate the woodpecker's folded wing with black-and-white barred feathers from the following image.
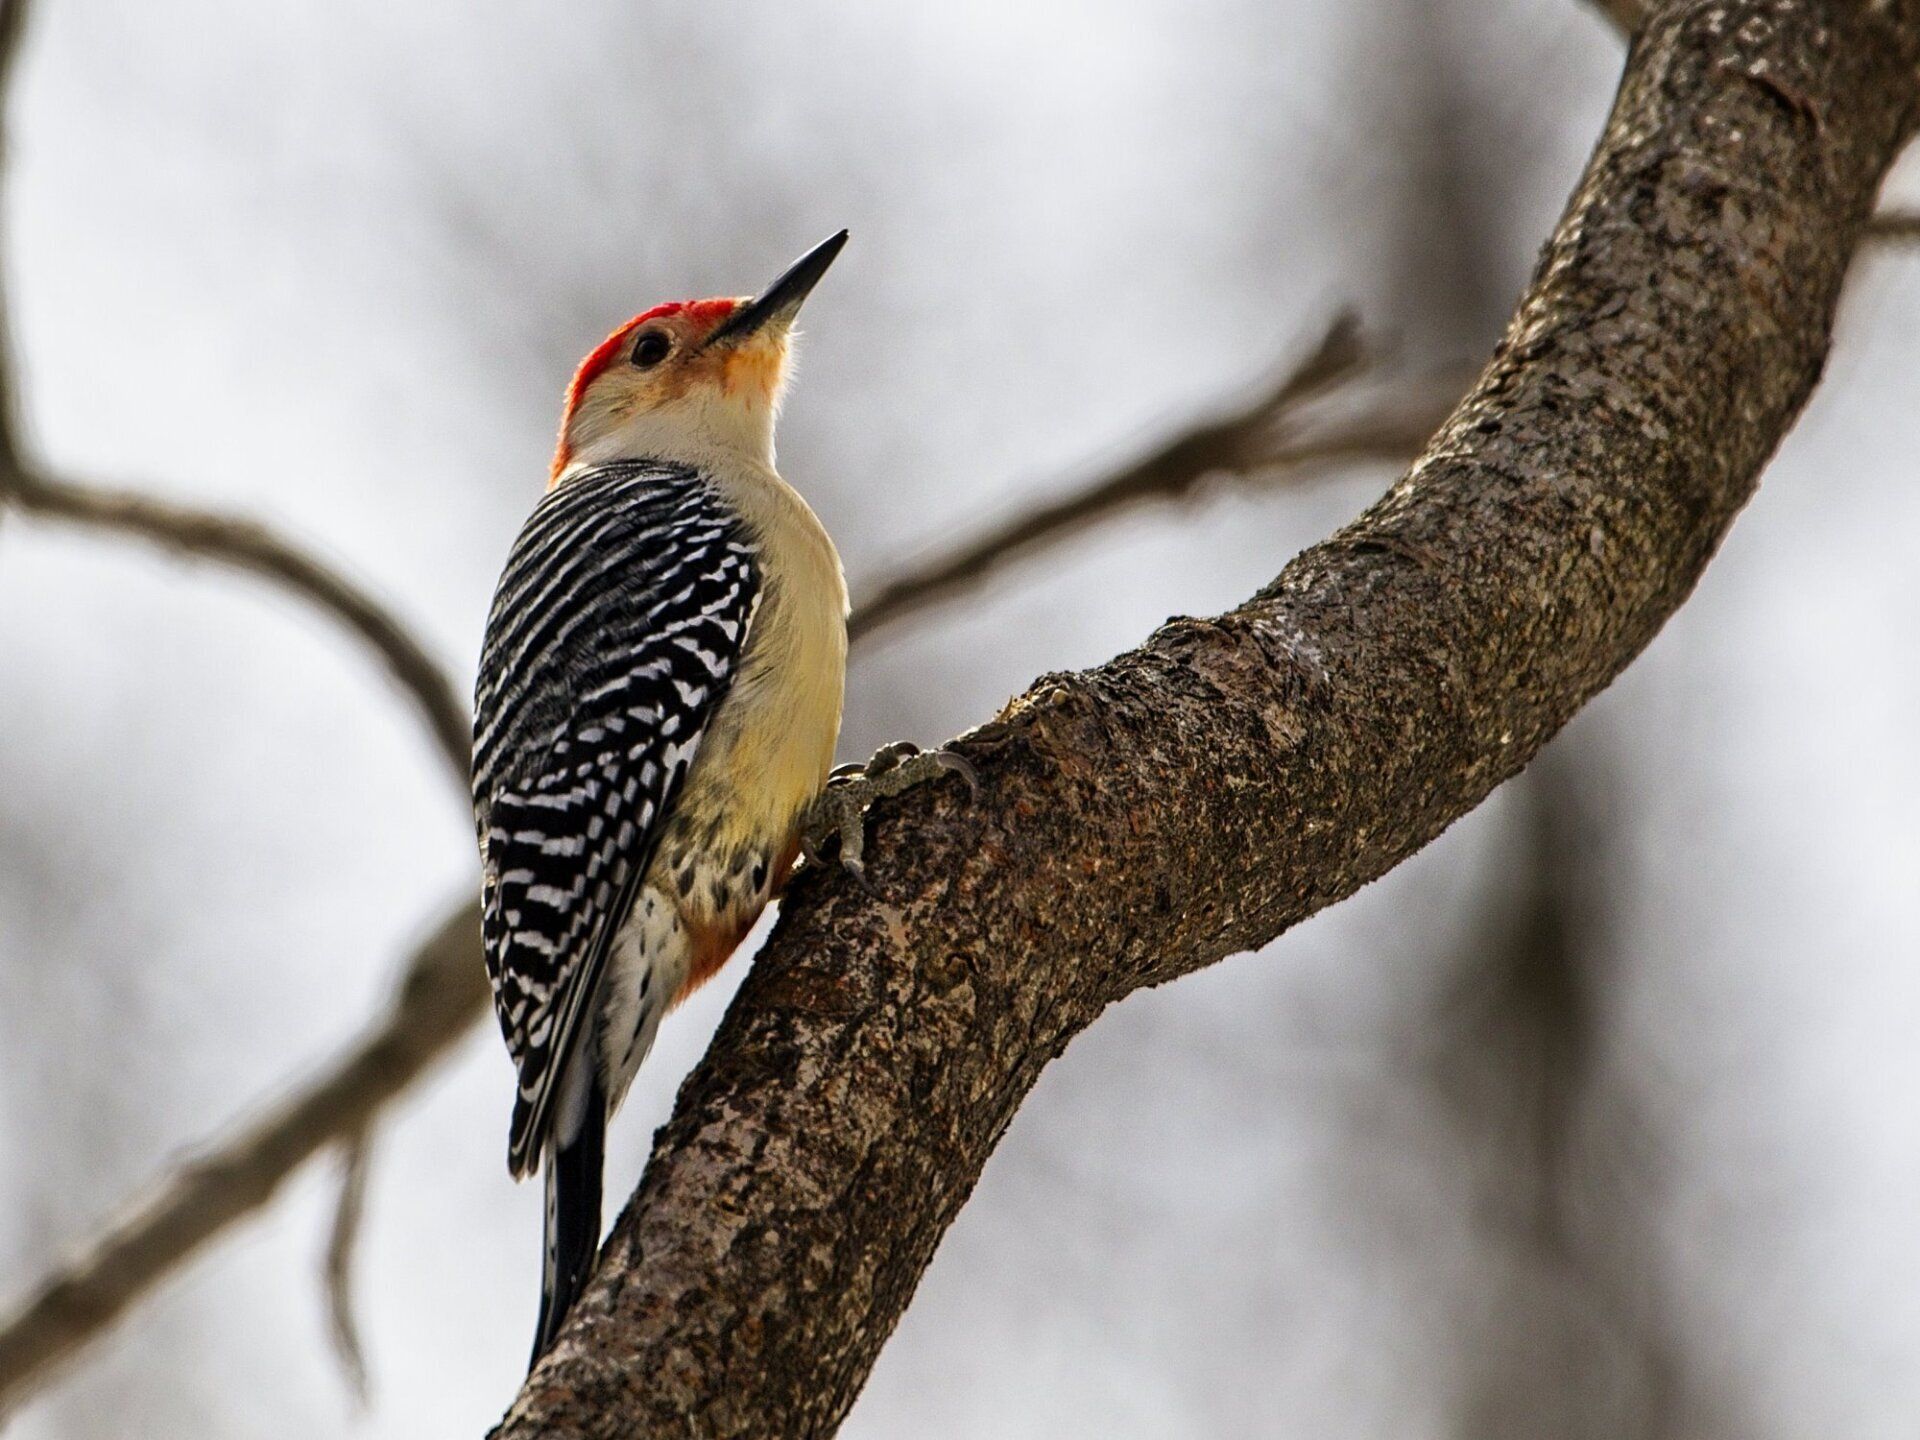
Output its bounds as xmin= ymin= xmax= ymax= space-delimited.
xmin=474 ymin=465 xmax=760 ymax=1175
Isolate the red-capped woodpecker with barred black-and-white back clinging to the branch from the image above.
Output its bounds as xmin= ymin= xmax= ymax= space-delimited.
xmin=472 ymin=230 xmax=973 ymax=1365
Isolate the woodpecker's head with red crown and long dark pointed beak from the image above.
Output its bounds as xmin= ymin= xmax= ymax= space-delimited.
xmin=549 ymin=230 xmax=847 ymax=488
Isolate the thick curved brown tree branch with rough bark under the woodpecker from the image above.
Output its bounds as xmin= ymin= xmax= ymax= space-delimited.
xmin=495 ymin=0 xmax=1920 ymax=1440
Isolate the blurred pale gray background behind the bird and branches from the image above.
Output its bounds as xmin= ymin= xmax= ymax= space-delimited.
xmin=0 ymin=0 xmax=1920 ymax=1440
